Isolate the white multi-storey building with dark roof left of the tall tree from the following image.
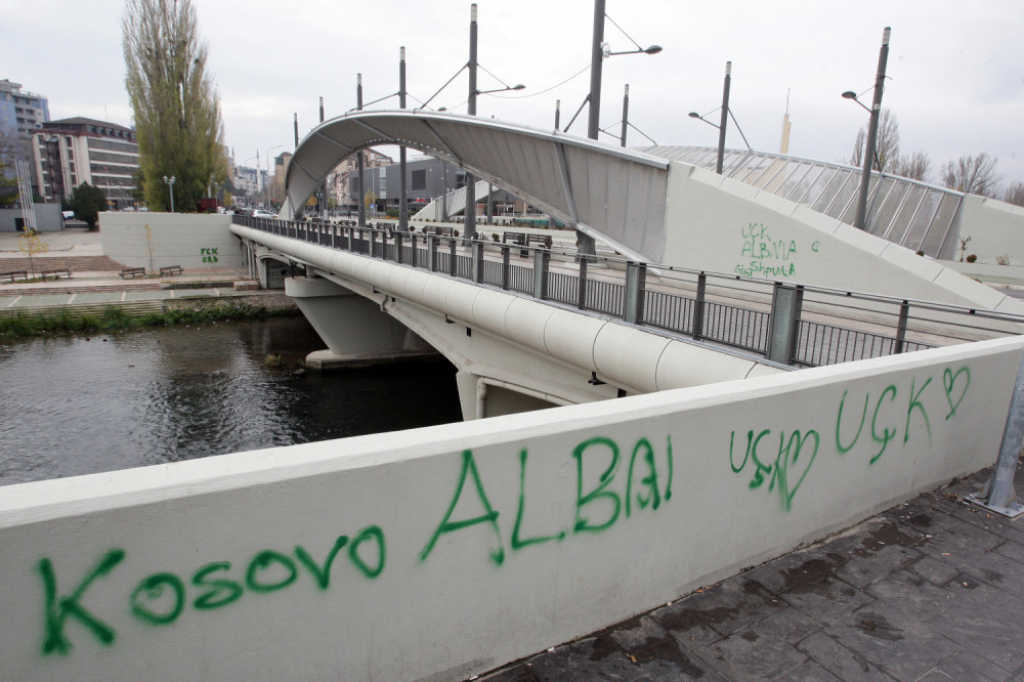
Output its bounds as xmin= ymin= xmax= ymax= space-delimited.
xmin=32 ymin=118 xmax=138 ymax=209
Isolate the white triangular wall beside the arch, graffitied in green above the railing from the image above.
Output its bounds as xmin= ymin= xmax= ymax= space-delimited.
xmin=666 ymin=163 xmax=1024 ymax=313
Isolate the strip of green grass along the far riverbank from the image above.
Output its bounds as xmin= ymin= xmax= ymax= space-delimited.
xmin=0 ymin=305 xmax=299 ymax=341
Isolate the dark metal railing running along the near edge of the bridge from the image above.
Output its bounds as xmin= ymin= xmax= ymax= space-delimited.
xmin=233 ymin=216 xmax=1024 ymax=367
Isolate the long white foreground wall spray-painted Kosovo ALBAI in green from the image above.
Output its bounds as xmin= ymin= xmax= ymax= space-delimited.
xmin=0 ymin=338 xmax=1024 ymax=682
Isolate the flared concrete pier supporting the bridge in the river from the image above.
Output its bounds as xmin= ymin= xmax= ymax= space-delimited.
xmin=285 ymin=278 xmax=437 ymax=370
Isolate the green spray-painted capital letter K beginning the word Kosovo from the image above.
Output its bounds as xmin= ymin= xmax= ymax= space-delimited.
xmin=39 ymin=549 xmax=125 ymax=654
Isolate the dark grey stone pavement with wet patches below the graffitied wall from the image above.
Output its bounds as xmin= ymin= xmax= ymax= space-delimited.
xmin=478 ymin=463 xmax=1024 ymax=682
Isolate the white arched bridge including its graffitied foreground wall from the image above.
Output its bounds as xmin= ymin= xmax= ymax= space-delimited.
xmin=0 ymin=109 xmax=1024 ymax=680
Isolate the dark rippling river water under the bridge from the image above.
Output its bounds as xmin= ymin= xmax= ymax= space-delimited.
xmin=0 ymin=316 xmax=462 ymax=485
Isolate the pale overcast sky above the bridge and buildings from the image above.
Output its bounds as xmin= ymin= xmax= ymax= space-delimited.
xmin=8 ymin=0 xmax=1024 ymax=183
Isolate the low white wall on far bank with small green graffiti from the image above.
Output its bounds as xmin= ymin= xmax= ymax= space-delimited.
xmin=99 ymin=212 xmax=243 ymax=273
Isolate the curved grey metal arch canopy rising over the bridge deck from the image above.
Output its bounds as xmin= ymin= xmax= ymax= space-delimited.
xmin=281 ymin=110 xmax=669 ymax=262
